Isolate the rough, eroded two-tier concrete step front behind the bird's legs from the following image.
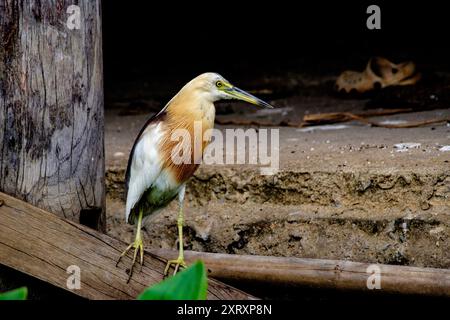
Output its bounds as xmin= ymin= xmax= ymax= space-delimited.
xmin=107 ymin=164 xmax=450 ymax=268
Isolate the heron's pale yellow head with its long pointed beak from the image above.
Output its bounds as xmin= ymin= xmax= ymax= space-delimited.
xmin=186 ymin=72 xmax=273 ymax=108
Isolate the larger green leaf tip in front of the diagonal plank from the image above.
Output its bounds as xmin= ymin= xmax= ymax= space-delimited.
xmin=138 ymin=261 xmax=208 ymax=300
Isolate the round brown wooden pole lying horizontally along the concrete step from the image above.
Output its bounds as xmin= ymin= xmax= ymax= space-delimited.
xmin=152 ymin=249 xmax=450 ymax=297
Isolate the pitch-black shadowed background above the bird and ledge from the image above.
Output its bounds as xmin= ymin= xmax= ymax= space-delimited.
xmin=103 ymin=0 xmax=450 ymax=101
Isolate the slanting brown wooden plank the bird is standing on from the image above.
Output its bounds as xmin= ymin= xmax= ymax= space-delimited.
xmin=0 ymin=193 xmax=254 ymax=299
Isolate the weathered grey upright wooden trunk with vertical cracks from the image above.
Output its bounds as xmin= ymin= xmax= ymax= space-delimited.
xmin=0 ymin=0 xmax=105 ymax=230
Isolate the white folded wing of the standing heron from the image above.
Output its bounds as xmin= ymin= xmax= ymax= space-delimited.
xmin=125 ymin=122 xmax=163 ymax=221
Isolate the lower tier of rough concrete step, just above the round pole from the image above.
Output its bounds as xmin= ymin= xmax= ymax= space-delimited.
xmin=107 ymin=199 xmax=450 ymax=268
